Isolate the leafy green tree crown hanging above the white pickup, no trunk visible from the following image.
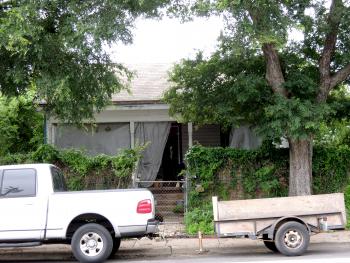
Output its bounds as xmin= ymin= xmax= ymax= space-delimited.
xmin=0 ymin=0 xmax=167 ymax=122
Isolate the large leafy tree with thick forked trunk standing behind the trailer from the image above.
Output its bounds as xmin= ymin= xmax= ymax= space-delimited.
xmin=165 ymin=0 xmax=350 ymax=195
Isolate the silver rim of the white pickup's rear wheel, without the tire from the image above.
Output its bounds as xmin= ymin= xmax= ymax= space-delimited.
xmin=80 ymin=232 xmax=103 ymax=257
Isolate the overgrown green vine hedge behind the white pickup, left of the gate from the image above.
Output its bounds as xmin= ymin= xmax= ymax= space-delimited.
xmin=0 ymin=144 xmax=144 ymax=190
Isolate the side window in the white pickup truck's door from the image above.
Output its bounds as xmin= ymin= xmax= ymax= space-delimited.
xmin=0 ymin=169 xmax=36 ymax=197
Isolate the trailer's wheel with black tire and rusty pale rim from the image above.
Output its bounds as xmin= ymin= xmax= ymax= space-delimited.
xmin=275 ymin=221 xmax=310 ymax=256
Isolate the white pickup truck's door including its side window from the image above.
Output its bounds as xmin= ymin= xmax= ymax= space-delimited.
xmin=0 ymin=168 xmax=47 ymax=241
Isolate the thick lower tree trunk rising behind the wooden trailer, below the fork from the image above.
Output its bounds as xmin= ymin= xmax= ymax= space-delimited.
xmin=289 ymin=138 xmax=312 ymax=196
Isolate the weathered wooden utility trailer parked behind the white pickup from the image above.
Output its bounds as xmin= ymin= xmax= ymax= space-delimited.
xmin=212 ymin=193 xmax=346 ymax=256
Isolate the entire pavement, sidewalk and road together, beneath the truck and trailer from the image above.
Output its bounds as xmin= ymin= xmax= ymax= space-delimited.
xmin=0 ymin=231 xmax=350 ymax=263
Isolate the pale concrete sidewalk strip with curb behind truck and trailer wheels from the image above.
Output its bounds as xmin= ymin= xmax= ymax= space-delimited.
xmin=0 ymin=231 xmax=350 ymax=262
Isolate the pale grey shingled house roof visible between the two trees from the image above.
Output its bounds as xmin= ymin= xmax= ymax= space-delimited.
xmin=112 ymin=63 xmax=172 ymax=104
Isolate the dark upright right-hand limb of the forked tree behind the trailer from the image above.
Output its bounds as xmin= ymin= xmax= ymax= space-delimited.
xmin=317 ymin=0 xmax=343 ymax=102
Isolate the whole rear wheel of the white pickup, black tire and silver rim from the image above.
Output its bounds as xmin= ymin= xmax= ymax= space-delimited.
xmin=71 ymin=223 xmax=113 ymax=263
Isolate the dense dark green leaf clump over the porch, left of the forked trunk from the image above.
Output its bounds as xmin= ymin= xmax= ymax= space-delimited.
xmin=165 ymin=52 xmax=270 ymax=126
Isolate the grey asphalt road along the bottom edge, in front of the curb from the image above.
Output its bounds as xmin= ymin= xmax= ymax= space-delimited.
xmin=0 ymin=243 xmax=350 ymax=263
